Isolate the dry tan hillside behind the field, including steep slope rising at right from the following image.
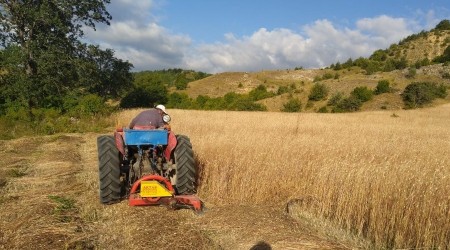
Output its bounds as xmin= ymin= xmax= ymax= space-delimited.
xmin=173 ymin=21 xmax=450 ymax=112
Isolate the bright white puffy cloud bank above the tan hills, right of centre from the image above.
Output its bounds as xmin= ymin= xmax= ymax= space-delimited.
xmin=186 ymin=17 xmax=411 ymax=72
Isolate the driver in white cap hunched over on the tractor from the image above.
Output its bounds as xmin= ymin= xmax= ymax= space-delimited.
xmin=128 ymin=104 xmax=170 ymax=130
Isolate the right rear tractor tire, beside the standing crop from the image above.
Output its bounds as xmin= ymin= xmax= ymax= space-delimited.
xmin=174 ymin=135 xmax=197 ymax=194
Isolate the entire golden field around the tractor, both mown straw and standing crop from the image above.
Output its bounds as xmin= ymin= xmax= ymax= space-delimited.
xmin=0 ymin=104 xmax=450 ymax=249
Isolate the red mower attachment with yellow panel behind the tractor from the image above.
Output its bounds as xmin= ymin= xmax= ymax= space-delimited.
xmin=129 ymin=175 xmax=203 ymax=212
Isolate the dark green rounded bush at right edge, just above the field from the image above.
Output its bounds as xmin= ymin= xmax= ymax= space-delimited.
xmin=402 ymin=82 xmax=447 ymax=108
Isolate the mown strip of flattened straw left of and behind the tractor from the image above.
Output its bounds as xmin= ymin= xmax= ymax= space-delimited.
xmin=0 ymin=134 xmax=347 ymax=249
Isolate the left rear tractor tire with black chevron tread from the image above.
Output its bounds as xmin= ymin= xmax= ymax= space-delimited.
xmin=97 ymin=135 xmax=123 ymax=204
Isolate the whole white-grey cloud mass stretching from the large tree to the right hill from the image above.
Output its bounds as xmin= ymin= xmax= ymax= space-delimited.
xmin=82 ymin=0 xmax=435 ymax=73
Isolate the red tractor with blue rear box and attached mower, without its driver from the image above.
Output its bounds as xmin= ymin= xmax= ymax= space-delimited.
xmin=97 ymin=128 xmax=203 ymax=212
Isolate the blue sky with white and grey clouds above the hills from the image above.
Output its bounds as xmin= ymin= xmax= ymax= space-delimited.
xmin=85 ymin=0 xmax=450 ymax=74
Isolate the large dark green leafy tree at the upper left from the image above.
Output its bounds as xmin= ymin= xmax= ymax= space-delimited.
xmin=0 ymin=0 xmax=132 ymax=108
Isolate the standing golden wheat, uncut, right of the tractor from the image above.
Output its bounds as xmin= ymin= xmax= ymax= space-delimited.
xmin=116 ymin=104 xmax=450 ymax=249
